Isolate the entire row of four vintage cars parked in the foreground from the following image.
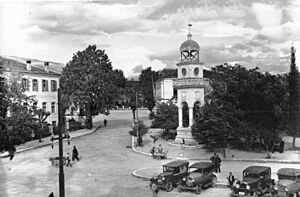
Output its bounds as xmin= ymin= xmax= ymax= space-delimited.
xmin=150 ymin=160 xmax=300 ymax=197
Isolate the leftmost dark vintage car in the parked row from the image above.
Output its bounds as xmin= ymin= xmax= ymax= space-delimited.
xmin=150 ymin=160 xmax=189 ymax=192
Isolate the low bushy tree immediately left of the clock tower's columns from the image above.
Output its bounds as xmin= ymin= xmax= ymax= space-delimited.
xmin=152 ymin=103 xmax=178 ymax=139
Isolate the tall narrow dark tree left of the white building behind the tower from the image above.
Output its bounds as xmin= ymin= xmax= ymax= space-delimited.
xmin=139 ymin=67 xmax=158 ymax=112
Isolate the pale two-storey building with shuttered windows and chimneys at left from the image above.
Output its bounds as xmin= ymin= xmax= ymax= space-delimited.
xmin=0 ymin=57 xmax=60 ymax=125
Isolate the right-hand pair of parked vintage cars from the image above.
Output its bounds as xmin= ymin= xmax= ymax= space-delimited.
xmin=231 ymin=166 xmax=300 ymax=197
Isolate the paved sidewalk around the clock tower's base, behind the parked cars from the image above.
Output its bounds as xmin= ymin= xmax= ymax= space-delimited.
xmin=136 ymin=130 xmax=300 ymax=164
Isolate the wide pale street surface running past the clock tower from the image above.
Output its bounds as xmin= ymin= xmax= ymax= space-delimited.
xmin=0 ymin=110 xmax=299 ymax=197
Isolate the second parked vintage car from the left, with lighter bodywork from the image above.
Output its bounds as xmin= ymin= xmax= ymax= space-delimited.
xmin=177 ymin=162 xmax=217 ymax=194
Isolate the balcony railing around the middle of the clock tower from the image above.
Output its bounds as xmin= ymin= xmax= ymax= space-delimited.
xmin=173 ymin=78 xmax=209 ymax=88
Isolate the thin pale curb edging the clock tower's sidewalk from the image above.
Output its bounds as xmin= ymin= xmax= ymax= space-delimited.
xmin=131 ymin=136 xmax=300 ymax=164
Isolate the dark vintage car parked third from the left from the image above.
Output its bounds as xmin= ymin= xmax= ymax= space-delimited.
xmin=231 ymin=166 xmax=274 ymax=196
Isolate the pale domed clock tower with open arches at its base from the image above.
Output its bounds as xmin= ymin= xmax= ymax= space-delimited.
xmin=173 ymin=24 xmax=209 ymax=145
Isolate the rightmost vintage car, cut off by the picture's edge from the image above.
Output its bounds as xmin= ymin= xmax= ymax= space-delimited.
xmin=274 ymin=168 xmax=300 ymax=197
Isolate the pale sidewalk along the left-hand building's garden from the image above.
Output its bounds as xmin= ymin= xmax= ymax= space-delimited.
xmin=0 ymin=122 xmax=100 ymax=158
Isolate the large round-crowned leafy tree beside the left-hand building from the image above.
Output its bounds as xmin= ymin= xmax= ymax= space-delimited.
xmin=60 ymin=45 xmax=123 ymax=128
